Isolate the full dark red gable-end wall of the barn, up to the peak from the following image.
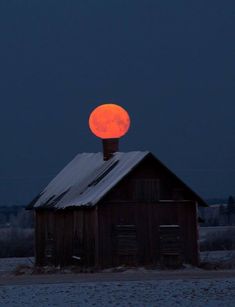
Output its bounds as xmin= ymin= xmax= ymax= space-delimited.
xmin=95 ymin=157 xmax=198 ymax=266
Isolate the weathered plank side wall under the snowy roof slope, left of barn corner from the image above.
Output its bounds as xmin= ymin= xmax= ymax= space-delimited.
xmin=35 ymin=209 xmax=95 ymax=266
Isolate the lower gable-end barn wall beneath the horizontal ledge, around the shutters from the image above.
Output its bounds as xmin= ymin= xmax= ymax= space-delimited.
xmin=98 ymin=202 xmax=198 ymax=267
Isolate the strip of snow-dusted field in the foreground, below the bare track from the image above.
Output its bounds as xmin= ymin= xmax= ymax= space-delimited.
xmin=0 ymin=278 xmax=235 ymax=307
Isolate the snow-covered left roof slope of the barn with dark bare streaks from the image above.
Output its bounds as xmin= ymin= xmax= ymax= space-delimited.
xmin=33 ymin=151 xmax=149 ymax=209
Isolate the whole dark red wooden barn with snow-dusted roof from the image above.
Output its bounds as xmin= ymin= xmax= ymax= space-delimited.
xmin=28 ymin=145 xmax=206 ymax=268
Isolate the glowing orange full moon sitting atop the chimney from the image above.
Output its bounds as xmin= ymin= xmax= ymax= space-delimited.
xmin=89 ymin=104 xmax=130 ymax=139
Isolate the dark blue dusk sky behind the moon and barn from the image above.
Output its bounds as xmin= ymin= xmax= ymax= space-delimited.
xmin=0 ymin=0 xmax=235 ymax=204
